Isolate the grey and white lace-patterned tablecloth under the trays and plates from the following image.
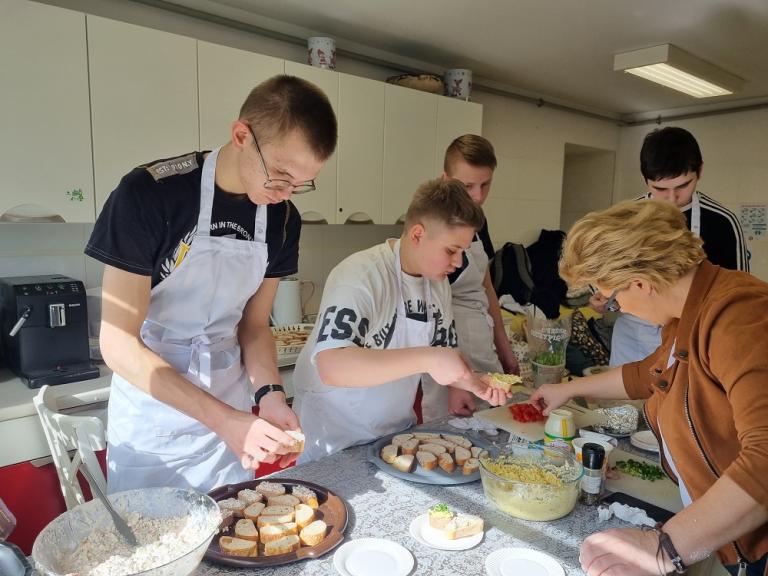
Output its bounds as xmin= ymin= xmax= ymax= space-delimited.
xmin=195 ymin=424 xmax=629 ymax=576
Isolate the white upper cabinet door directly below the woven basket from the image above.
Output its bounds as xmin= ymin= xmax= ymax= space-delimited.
xmin=382 ymin=84 xmax=439 ymax=224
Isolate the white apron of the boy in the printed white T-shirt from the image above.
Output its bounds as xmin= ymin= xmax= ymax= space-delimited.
xmin=293 ymin=240 xmax=435 ymax=464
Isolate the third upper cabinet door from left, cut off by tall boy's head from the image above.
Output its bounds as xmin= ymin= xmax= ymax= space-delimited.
xmin=197 ymin=41 xmax=285 ymax=150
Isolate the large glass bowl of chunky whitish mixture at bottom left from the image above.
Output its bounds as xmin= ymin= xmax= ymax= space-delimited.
xmin=32 ymin=488 xmax=221 ymax=576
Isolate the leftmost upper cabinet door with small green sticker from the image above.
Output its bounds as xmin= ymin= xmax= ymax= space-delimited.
xmin=0 ymin=0 xmax=94 ymax=222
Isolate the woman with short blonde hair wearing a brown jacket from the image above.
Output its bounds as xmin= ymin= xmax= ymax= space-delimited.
xmin=531 ymin=201 xmax=768 ymax=576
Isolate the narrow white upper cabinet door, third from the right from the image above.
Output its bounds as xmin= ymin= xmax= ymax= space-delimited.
xmin=337 ymin=74 xmax=385 ymax=224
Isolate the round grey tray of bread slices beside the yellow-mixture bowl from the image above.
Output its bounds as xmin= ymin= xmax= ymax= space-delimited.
xmin=368 ymin=428 xmax=489 ymax=485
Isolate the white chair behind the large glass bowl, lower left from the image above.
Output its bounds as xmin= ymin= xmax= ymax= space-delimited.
xmin=34 ymin=386 xmax=107 ymax=510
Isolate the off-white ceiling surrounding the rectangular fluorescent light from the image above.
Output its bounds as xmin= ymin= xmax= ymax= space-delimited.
xmin=162 ymin=0 xmax=768 ymax=119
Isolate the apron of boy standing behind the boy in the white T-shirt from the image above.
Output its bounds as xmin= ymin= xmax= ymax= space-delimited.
xmin=421 ymin=236 xmax=503 ymax=422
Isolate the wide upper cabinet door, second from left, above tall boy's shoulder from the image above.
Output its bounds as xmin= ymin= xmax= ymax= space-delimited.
xmin=88 ymin=15 xmax=200 ymax=213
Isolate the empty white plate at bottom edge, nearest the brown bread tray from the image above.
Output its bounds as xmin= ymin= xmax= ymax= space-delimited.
xmin=333 ymin=538 xmax=413 ymax=576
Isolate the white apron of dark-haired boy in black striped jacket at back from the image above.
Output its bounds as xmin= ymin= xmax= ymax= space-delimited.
xmin=609 ymin=191 xmax=701 ymax=366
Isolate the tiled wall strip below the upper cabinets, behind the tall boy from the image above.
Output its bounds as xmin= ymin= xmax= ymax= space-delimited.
xmin=0 ymin=223 xmax=401 ymax=314
